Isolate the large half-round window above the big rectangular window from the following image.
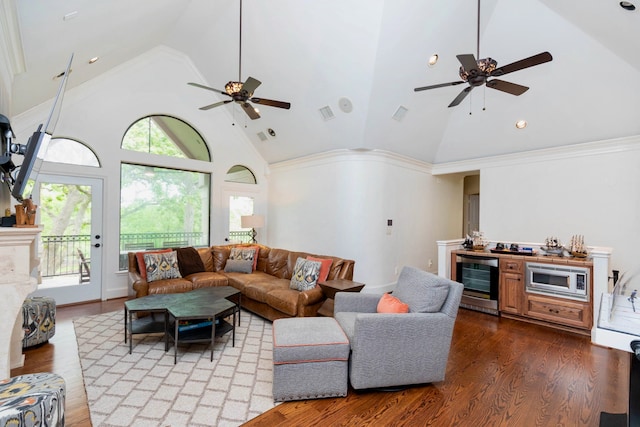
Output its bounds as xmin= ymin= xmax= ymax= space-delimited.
xmin=122 ymin=116 xmax=211 ymax=162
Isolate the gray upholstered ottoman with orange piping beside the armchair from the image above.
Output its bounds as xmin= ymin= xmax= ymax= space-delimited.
xmin=273 ymin=317 xmax=349 ymax=401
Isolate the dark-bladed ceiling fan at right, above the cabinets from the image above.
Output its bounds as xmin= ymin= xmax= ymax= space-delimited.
xmin=414 ymin=0 xmax=553 ymax=107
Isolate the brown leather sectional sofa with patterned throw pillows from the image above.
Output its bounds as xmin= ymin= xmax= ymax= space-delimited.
xmin=128 ymin=245 xmax=355 ymax=321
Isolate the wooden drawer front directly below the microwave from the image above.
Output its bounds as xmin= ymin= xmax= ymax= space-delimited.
xmin=525 ymin=293 xmax=592 ymax=329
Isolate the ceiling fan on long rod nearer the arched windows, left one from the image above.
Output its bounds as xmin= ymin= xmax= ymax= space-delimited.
xmin=187 ymin=0 xmax=291 ymax=120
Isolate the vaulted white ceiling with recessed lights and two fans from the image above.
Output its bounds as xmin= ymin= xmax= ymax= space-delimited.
xmin=0 ymin=0 xmax=640 ymax=163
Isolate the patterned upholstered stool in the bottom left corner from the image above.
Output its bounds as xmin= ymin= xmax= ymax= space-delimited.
xmin=0 ymin=372 xmax=66 ymax=427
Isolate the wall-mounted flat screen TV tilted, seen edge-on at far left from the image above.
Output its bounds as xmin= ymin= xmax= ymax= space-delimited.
xmin=11 ymin=54 xmax=73 ymax=202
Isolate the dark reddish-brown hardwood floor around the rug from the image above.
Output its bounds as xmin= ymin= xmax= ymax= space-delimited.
xmin=11 ymin=299 xmax=630 ymax=427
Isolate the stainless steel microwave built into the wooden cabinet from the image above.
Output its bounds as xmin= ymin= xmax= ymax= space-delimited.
xmin=525 ymin=262 xmax=589 ymax=301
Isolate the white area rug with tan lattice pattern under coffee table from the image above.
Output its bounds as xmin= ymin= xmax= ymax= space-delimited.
xmin=74 ymin=311 xmax=275 ymax=427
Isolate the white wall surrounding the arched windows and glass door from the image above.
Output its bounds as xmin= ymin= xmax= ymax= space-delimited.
xmin=3 ymin=47 xmax=267 ymax=299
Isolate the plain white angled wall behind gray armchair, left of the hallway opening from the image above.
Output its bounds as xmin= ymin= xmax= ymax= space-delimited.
xmin=268 ymin=150 xmax=463 ymax=292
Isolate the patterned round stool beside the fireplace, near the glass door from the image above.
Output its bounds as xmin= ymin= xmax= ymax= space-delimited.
xmin=22 ymin=297 xmax=56 ymax=348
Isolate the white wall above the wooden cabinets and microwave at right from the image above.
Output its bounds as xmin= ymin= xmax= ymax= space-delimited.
xmin=480 ymin=137 xmax=640 ymax=284
